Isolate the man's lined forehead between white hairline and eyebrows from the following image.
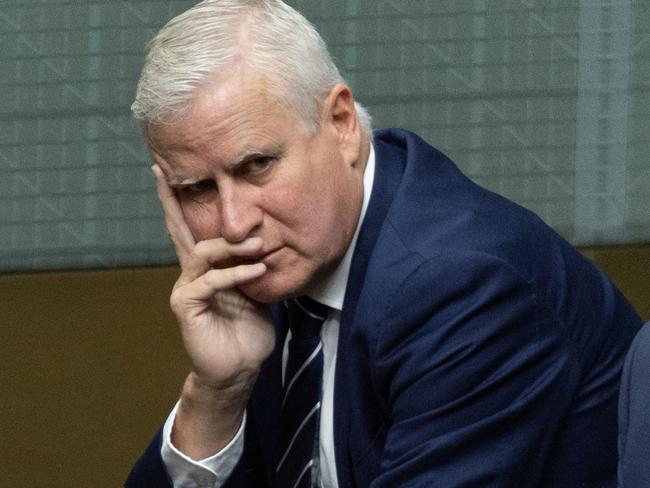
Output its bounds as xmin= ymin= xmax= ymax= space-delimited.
xmin=146 ymin=76 xmax=302 ymax=165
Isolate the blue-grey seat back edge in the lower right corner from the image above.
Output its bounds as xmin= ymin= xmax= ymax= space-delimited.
xmin=618 ymin=322 xmax=650 ymax=488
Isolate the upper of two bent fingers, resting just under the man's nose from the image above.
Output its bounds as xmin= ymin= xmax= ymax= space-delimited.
xmin=178 ymin=237 xmax=262 ymax=286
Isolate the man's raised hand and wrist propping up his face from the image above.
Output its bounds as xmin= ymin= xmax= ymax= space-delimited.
xmin=152 ymin=165 xmax=275 ymax=458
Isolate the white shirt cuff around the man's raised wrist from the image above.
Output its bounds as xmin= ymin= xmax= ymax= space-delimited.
xmin=160 ymin=401 xmax=246 ymax=488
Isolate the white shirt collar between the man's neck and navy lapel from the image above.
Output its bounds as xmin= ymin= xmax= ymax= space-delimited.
xmin=305 ymin=144 xmax=375 ymax=312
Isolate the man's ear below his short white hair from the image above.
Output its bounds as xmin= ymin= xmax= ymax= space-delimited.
xmin=322 ymin=83 xmax=363 ymax=166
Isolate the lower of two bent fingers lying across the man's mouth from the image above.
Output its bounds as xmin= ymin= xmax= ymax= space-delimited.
xmin=171 ymin=263 xmax=266 ymax=308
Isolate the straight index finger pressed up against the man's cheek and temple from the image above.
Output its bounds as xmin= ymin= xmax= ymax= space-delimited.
xmin=151 ymin=164 xmax=196 ymax=266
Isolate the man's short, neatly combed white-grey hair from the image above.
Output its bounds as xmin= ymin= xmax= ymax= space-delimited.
xmin=131 ymin=0 xmax=371 ymax=134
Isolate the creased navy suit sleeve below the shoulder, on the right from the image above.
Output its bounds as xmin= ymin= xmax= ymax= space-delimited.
xmin=372 ymin=256 xmax=579 ymax=488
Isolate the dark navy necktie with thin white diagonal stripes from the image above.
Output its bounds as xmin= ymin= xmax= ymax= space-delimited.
xmin=276 ymin=297 xmax=329 ymax=488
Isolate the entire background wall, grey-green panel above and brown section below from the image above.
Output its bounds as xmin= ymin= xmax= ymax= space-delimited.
xmin=0 ymin=0 xmax=650 ymax=488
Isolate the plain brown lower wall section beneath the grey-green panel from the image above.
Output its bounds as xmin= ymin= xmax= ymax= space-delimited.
xmin=0 ymin=245 xmax=650 ymax=488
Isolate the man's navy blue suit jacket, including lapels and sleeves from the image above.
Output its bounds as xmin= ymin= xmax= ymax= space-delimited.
xmin=127 ymin=130 xmax=641 ymax=488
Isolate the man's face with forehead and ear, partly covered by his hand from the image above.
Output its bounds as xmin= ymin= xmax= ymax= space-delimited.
xmin=147 ymin=77 xmax=365 ymax=302
